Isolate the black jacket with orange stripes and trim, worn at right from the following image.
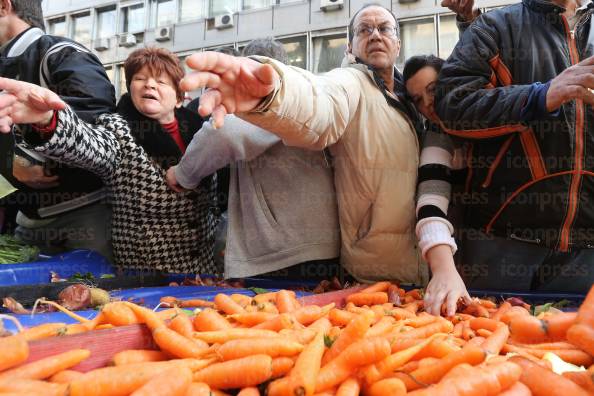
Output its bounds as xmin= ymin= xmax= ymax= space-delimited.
xmin=435 ymin=0 xmax=594 ymax=251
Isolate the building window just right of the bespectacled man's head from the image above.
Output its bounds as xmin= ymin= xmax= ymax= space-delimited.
xmin=396 ymin=17 xmax=437 ymax=68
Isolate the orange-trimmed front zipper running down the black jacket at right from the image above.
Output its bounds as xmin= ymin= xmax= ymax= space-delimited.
xmin=559 ymin=16 xmax=584 ymax=252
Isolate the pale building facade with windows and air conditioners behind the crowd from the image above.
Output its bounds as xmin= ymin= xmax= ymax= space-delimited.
xmin=43 ymin=0 xmax=517 ymax=96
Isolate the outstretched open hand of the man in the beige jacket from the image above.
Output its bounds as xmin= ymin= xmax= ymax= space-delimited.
xmin=180 ymin=52 xmax=279 ymax=128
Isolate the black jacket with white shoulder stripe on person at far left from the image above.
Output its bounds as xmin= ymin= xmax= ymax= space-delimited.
xmin=0 ymin=28 xmax=115 ymax=218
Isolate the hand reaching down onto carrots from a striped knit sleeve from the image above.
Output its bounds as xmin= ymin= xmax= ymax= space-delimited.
xmin=425 ymin=245 xmax=471 ymax=316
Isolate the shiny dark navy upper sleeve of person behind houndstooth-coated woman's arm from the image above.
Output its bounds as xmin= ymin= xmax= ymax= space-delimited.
xmin=48 ymin=46 xmax=115 ymax=122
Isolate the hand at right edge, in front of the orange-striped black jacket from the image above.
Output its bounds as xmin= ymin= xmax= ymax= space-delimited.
xmin=546 ymin=56 xmax=594 ymax=112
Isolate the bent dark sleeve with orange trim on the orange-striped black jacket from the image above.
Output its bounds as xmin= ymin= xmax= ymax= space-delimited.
xmin=435 ymin=15 xmax=531 ymax=139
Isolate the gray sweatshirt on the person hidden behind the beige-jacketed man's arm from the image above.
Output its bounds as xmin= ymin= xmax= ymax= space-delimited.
xmin=175 ymin=115 xmax=340 ymax=278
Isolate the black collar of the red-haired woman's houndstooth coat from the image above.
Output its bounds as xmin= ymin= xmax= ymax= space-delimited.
xmin=116 ymin=93 xmax=203 ymax=169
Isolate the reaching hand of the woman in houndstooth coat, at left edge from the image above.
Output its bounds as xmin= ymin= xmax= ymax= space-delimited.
xmin=0 ymin=77 xmax=66 ymax=133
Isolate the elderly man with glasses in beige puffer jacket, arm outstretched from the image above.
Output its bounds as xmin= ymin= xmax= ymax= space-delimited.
xmin=177 ymin=5 xmax=428 ymax=284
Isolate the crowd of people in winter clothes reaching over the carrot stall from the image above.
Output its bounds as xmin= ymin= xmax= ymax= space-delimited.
xmin=0 ymin=0 xmax=594 ymax=315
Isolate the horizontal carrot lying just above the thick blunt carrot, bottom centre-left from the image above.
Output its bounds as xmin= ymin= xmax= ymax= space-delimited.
xmin=217 ymin=337 xmax=303 ymax=360
